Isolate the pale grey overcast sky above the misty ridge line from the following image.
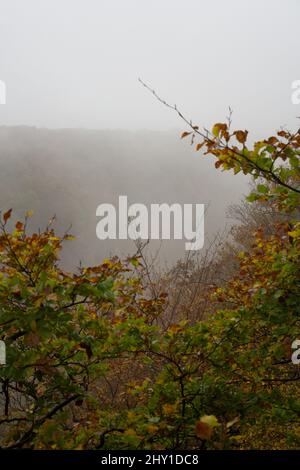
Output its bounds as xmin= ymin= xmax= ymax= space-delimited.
xmin=0 ymin=0 xmax=300 ymax=133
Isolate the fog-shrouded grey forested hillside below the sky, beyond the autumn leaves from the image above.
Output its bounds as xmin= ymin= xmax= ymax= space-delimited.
xmin=0 ymin=126 xmax=249 ymax=269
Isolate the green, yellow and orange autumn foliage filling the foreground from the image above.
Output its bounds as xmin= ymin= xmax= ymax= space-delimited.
xmin=0 ymin=122 xmax=300 ymax=449
